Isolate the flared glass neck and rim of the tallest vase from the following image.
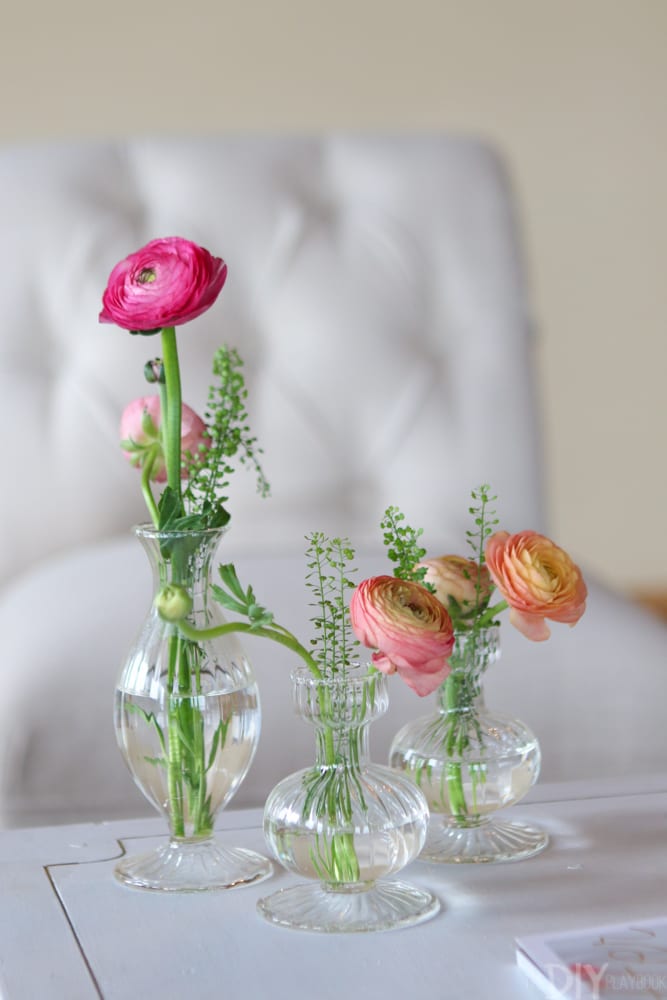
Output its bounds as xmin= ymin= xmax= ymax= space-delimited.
xmin=134 ymin=525 xmax=224 ymax=597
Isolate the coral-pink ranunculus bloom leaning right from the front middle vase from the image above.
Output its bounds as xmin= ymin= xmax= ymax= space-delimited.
xmin=350 ymin=576 xmax=454 ymax=696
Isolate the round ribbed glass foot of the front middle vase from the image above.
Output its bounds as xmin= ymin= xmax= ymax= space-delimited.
xmin=257 ymin=881 xmax=440 ymax=934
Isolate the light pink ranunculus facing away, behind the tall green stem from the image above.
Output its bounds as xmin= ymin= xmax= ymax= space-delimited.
xmin=120 ymin=396 xmax=208 ymax=483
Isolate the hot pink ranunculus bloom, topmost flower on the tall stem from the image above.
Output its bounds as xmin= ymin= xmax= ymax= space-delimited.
xmin=100 ymin=236 xmax=227 ymax=333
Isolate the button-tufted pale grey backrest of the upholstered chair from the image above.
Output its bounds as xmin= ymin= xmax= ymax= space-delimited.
xmin=0 ymin=134 xmax=543 ymax=581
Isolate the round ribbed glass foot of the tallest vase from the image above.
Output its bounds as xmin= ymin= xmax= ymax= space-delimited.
xmin=114 ymin=839 xmax=273 ymax=892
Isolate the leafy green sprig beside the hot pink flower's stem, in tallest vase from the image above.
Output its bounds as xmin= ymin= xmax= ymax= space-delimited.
xmin=183 ymin=346 xmax=270 ymax=527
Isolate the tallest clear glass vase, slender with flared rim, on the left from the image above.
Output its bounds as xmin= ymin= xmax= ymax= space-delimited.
xmin=114 ymin=525 xmax=272 ymax=891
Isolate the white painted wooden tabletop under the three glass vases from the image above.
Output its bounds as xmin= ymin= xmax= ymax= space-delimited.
xmin=0 ymin=779 xmax=667 ymax=1000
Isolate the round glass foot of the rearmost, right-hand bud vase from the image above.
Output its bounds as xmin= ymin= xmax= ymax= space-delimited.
xmin=419 ymin=818 xmax=549 ymax=864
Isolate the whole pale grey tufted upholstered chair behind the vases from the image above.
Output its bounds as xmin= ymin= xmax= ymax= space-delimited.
xmin=0 ymin=135 xmax=667 ymax=825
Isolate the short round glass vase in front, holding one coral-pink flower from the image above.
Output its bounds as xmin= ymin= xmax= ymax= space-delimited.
xmin=258 ymin=667 xmax=440 ymax=932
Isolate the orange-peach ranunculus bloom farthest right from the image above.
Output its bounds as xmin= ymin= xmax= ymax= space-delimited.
xmin=484 ymin=531 xmax=587 ymax=642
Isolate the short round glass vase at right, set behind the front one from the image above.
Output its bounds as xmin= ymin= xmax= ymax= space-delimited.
xmin=389 ymin=627 xmax=548 ymax=862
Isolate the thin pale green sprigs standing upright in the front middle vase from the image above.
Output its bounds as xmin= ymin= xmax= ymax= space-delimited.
xmin=306 ymin=531 xmax=359 ymax=673
